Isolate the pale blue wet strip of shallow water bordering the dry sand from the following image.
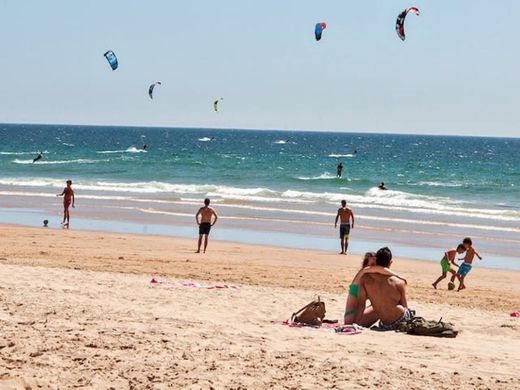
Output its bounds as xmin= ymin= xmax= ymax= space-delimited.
xmin=4 ymin=204 xmax=520 ymax=271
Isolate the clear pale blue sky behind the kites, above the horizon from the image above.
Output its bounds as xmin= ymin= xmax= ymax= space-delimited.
xmin=0 ymin=0 xmax=520 ymax=137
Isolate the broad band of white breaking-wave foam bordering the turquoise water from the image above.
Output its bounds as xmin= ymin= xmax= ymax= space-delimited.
xmin=0 ymin=178 xmax=520 ymax=222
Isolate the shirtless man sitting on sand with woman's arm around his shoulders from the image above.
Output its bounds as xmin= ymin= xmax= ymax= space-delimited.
xmin=354 ymin=247 xmax=413 ymax=330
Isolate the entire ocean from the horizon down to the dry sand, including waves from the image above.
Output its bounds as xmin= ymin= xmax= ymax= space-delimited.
xmin=0 ymin=124 xmax=520 ymax=268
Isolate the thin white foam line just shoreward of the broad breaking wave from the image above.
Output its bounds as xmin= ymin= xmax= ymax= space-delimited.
xmin=0 ymin=191 xmax=520 ymax=233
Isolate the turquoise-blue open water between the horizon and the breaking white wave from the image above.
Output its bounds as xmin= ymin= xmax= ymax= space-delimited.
xmin=0 ymin=125 xmax=520 ymax=206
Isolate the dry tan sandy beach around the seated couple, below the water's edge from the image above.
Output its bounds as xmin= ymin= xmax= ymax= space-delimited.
xmin=0 ymin=225 xmax=520 ymax=389
